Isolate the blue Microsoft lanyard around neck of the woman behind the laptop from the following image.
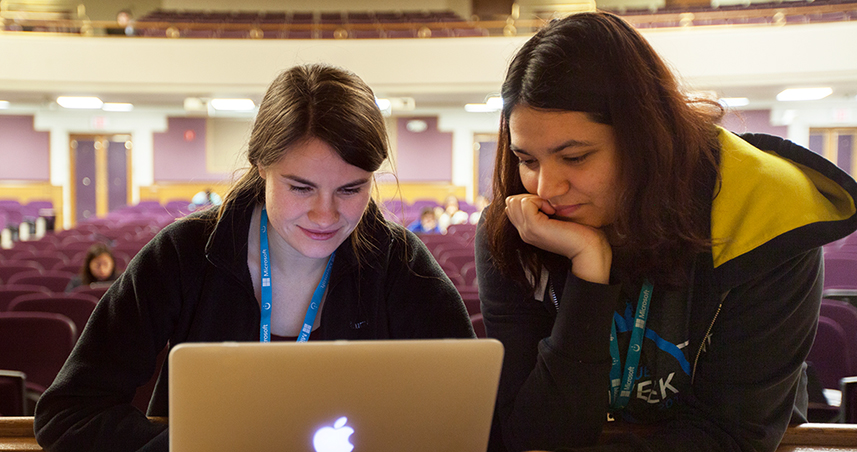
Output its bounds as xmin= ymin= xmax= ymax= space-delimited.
xmin=259 ymin=207 xmax=336 ymax=342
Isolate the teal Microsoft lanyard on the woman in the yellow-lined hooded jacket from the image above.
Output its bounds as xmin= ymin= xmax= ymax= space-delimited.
xmin=610 ymin=280 xmax=654 ymax=411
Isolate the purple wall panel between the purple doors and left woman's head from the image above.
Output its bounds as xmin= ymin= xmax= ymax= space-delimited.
xmin=154 ymin=118 xmax=228 ymax=182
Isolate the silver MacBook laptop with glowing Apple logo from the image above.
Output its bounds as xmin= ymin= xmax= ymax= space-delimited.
xmin=169 ymin=339 xmax=503 ymax=452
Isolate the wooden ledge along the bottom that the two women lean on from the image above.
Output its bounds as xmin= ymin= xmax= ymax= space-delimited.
xmin=0 ymin=417 xmax=857 ymax=452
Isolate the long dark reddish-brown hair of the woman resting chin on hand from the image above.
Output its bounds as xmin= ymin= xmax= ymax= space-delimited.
xmin=485 ymin=12 xmax=723 ymax=289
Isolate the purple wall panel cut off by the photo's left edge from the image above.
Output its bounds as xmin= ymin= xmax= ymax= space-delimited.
xmin=0 ymin=115 xmax=51 ymax=181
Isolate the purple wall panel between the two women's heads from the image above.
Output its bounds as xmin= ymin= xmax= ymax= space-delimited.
xmin=396 ymin=117 xmax=452 ymax=182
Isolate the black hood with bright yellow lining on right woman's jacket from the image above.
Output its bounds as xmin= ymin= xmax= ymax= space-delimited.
xmin=711 ymin=130 xmax=857 ymax=287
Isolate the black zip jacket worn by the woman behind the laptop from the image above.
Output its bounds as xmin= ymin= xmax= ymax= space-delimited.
xmin=35 ymin=195 xmax=474 ymax=451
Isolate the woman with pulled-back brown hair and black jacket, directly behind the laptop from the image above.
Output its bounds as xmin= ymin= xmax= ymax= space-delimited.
xmin=35 ymin=65 xmax=474 ymax=451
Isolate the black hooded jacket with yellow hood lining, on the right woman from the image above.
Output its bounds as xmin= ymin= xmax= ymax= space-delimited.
xmin=476 ymin=131 xmax=857 ymax=452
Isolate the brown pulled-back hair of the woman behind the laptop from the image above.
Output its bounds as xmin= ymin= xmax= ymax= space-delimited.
xmin=218 ymin=64 xmax=389 ymax=259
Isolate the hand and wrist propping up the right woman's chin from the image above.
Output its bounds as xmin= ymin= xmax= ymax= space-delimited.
xmin=506 ymin=194 xmax=613 ymax=284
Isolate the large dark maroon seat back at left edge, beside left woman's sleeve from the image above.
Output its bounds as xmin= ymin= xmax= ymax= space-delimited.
xmin=0 ymin=312 xmax=77 ymax=392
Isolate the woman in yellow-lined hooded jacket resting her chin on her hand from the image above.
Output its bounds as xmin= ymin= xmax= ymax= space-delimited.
xmin=476 ymin=13 xmax=857 ymax=451
